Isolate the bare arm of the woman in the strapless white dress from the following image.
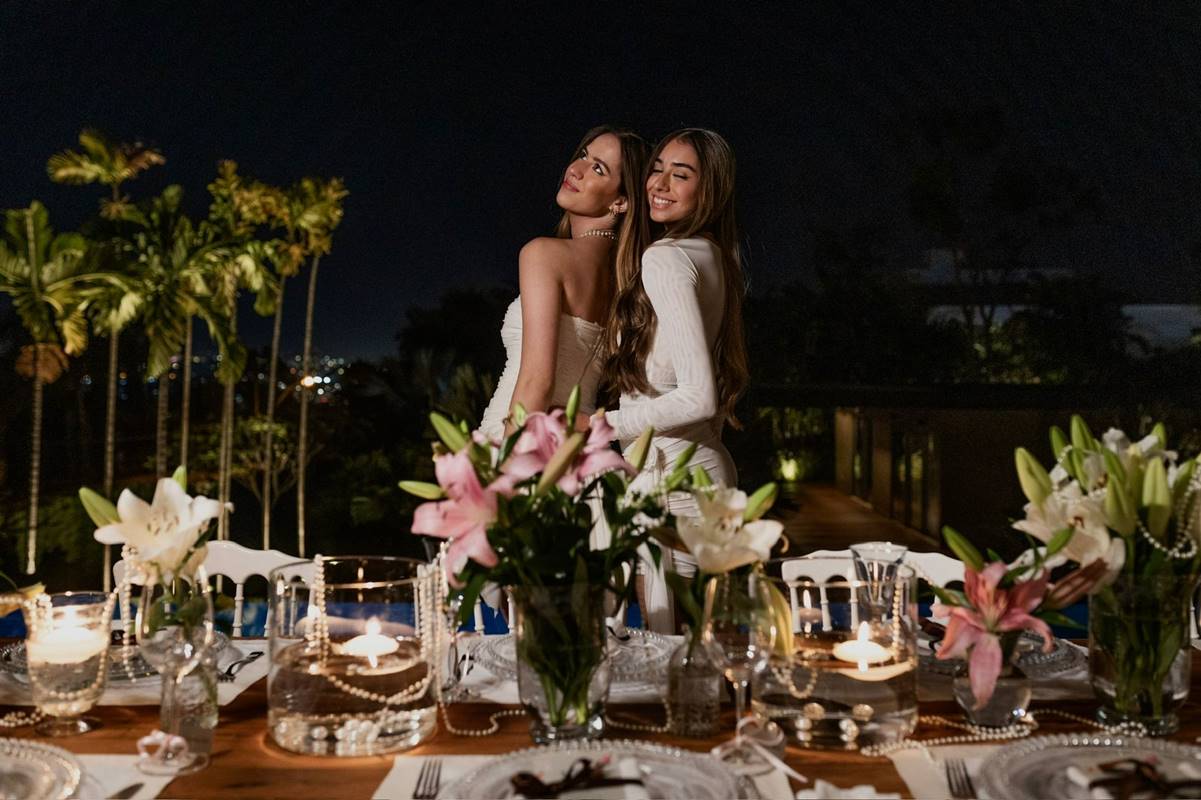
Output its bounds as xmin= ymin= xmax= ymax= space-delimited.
xmin=506 ymin=239 xmax=563 ymax=432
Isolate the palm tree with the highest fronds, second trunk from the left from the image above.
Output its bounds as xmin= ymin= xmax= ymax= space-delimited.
xmin=46 ymin=130 xmax=162 ymax=591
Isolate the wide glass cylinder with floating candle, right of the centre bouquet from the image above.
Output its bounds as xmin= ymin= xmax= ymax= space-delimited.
xmin=752 ymin=559 xmax=918 ymax=750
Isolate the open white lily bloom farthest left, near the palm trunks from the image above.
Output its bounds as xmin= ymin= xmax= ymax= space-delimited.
xmin=95 ymin=478 xmax=221 ymax=581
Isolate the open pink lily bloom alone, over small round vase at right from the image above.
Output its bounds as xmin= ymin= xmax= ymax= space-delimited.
xmin=933 ymin=561 xmax=1054 ymax=709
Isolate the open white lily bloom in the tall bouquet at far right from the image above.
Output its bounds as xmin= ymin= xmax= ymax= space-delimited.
xmin=1014 ymin=480 xmax=1125 ymax=573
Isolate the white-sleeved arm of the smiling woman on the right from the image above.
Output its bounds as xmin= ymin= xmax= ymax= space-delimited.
xmin=609 ymin=245 xmax=717 ymax=440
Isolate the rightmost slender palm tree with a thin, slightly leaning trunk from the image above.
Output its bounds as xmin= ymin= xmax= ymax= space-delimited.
xmin=291 ymin=178 xmax=348 ymax=557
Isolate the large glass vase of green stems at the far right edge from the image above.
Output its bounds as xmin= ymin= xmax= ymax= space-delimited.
xmin=1088 ymin=574 xmax=1196 ymax=736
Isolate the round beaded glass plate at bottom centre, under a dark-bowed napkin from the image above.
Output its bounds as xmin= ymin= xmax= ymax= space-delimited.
xmin=438 ymin=741 xmax=740 ymax=800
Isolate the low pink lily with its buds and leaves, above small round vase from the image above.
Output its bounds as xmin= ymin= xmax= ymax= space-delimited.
xmin=932 ymin=527 xmax=1105 ymax=709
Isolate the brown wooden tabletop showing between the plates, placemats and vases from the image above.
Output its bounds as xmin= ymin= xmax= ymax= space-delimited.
xmin=5 ymin=653 xmax=1201 ymax=800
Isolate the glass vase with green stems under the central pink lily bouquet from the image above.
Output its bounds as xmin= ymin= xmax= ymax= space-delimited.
xmin=510 ymin=584 xmax=609 ymax=745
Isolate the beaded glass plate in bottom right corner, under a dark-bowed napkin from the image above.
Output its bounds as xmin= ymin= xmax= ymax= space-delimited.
xmin=979 ymin=734 xmax=1201 ymax=800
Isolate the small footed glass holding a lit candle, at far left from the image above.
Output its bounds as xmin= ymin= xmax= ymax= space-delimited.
xmin=24 ymin=592 xmax=115 ymax=736
